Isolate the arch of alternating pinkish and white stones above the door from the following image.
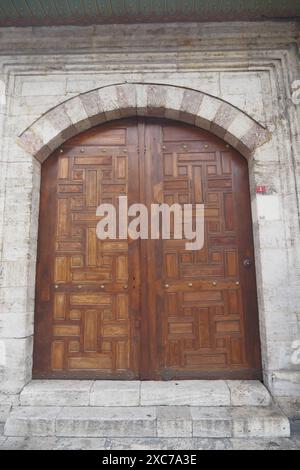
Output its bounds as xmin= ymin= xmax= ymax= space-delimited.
xmin=18 ymin=82 xmax=270 ymax=162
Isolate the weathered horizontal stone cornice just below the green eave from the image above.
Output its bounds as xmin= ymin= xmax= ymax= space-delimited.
xmin=0 ymin=21 xmax=300 ymax=55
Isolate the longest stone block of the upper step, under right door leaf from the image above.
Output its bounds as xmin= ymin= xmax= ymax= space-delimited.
xmin=141 ymin=380 xmax=230 ymax=406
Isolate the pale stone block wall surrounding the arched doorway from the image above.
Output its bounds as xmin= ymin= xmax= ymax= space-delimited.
xmin=0 ymin=22 xmax=300 ymax=406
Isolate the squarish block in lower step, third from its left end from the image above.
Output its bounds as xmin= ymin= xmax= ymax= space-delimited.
xmin=157 ymin=406 xmax=192 ymax=437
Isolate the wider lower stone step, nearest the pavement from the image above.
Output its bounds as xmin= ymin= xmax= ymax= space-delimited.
xmin=4 ymin=405 xmax=290 ymax=438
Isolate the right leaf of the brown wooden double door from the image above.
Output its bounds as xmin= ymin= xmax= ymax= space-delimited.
xmin=145 ymin=123 xmax=260 ymax=379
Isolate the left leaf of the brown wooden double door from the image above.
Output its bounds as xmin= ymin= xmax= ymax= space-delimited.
xmin=35 ymin=118 xmax=138 ymax=378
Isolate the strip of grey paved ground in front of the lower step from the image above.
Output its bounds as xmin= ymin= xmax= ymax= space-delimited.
xmin=0 ymin=434 xmax=300 ymax=450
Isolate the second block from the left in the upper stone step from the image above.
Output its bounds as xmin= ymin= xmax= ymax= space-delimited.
xmin=90 ymin=380 xmax=140 ymax=406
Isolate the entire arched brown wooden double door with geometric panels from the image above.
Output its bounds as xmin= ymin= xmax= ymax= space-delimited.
xmin=34 ymin=118 xmax=261 ymax=380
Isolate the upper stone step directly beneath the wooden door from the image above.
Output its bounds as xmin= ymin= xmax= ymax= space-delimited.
xmin=20 ymin=380 xmax=272 ymax=407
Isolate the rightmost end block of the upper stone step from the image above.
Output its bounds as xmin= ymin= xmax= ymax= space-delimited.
xmin=227 ymin=380 xmax=272 ymax=406
